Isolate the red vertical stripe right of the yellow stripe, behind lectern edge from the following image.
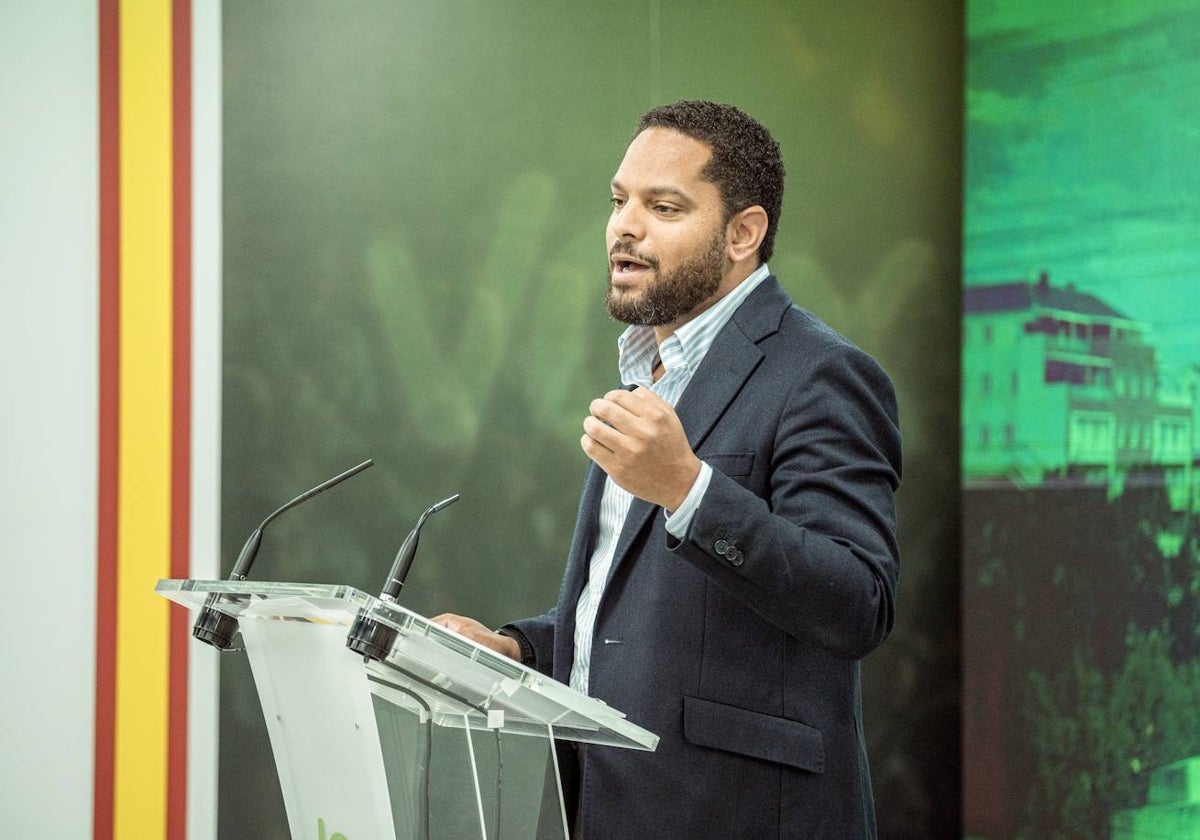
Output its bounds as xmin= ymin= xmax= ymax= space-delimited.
xmin=167 ymin=0 xmax=192 ymax=840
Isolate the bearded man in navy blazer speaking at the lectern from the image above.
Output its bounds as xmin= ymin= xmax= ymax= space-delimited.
xmin=437 ymin=102 xmax=900 ymax=840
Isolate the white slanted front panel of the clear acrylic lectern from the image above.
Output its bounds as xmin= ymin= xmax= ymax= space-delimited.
xmin=240 ymin=607 xmax=396 ymax=840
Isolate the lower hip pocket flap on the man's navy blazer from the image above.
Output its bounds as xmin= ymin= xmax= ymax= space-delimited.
xmin=683 ymin=697 xmax=824 ymax=773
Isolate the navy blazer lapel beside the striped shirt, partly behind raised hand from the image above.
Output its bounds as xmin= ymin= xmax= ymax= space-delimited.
xmin=600 ymin=276 xmax=792 ymax=587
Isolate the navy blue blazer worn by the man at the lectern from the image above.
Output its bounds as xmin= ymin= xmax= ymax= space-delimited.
xmin=511 ymin=277 xmax=900 ymax=840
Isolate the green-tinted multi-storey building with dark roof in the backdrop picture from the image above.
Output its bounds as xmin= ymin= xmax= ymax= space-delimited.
xmin=962 ymin=272 xmax=1196 ymax=510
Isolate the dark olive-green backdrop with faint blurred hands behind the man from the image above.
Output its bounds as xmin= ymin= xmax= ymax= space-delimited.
xmin=220 ymin=0 xmax=962 ymax=838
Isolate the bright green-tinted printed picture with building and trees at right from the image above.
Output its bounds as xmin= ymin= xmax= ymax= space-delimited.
xmin=961 ymin=0 xmax=1200 ymax=840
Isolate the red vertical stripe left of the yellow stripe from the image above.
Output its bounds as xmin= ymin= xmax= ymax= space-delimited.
xmin=92 ymin=0 xmax=121 ymax=840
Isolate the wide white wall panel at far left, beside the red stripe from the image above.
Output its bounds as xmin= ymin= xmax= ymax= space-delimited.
xmin=0 ymin=0 xmax=98 ymax=838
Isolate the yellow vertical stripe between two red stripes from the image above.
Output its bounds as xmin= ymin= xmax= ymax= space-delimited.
xmin=113 ymin=0 xmax=172 ymax=839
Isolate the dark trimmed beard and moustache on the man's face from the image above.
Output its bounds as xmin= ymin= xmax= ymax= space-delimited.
xmin=605 ymin=228 xmax=725 ymax=326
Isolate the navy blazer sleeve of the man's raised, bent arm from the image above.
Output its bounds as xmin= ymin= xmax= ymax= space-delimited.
xmin=667 ymin=342 xmax=901 ymax=659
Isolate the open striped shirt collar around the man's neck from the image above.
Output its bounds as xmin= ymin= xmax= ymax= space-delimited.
xmin=617 ymin=263 xmax=770 ymax=388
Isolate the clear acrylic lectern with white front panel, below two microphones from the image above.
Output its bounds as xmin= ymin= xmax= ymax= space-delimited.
xmin=156 ymin=581 xmax=658 ymax=840
